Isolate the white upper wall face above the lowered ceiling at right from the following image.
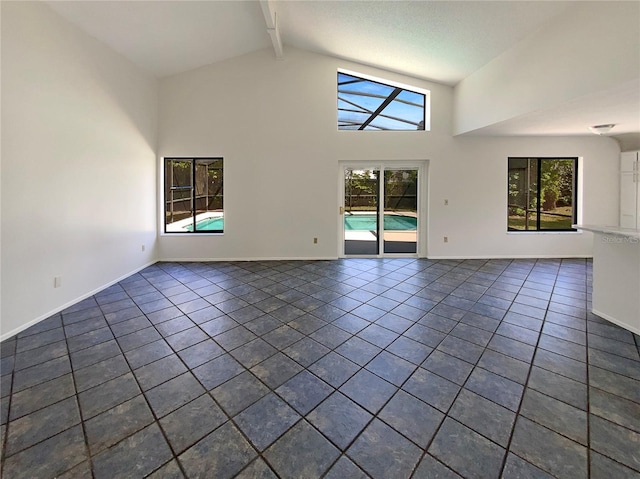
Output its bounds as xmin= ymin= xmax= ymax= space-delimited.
xmin=454 ymin=1 xmax=640 ymax=134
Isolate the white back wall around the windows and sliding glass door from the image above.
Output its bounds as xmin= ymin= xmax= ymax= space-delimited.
xmin=158 ymin=48 xmax=619 ymax=260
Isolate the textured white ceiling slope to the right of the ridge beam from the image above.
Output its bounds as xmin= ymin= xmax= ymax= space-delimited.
xmin=277 ymin=1 xmax=571 ymax=85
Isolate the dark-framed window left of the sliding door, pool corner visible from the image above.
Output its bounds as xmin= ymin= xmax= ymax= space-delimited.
xmin=164 ymin=158 xmax=224 ymax=233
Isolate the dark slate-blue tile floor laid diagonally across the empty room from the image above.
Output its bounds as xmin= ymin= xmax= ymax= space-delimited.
xmin=0 ymin=259 xmax=640 ymax=479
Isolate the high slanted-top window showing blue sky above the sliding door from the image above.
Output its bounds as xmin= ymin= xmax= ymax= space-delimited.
xmin=338 ymin=71 xmax=429 ymax=130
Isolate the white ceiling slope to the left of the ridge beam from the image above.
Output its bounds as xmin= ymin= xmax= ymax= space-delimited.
xmin=46 ymin=1 xmax=271 ymax=78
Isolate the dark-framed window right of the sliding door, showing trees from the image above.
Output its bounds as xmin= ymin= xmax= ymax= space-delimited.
xmin=507 ymin=158 xmax=578 ymax=231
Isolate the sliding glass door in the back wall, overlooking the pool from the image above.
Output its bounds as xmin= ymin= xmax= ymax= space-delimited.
xmin=341 ymin=166 xmax=419 ymax=256
